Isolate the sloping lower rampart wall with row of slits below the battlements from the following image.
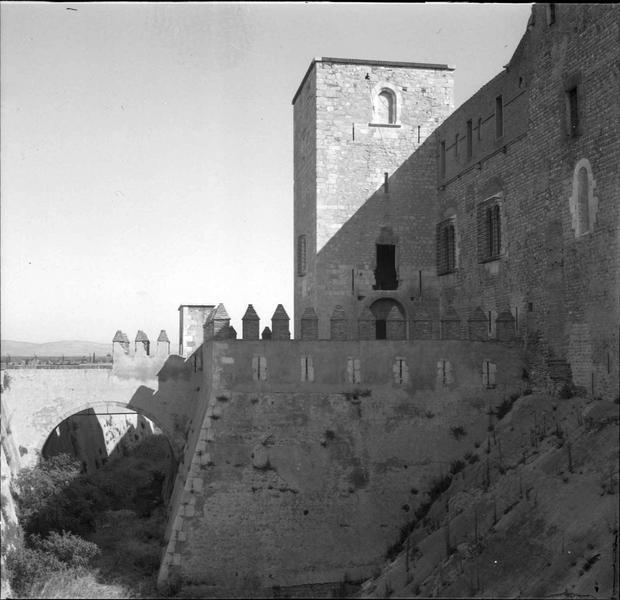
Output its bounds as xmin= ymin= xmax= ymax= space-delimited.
xmin=160 ymin=340 xmax=522 ymax=595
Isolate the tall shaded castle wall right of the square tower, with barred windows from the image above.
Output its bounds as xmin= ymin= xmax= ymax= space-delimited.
xmin=436 ymin=5 xmax=620 ymax=398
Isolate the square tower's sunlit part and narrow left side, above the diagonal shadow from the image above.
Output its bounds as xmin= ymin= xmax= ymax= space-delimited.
xmin=293 ymin=58 xmax=453 ymax=337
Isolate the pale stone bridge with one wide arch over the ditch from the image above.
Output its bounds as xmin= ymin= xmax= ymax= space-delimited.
xmin=2 ymin=355 xmax=200 ymax=467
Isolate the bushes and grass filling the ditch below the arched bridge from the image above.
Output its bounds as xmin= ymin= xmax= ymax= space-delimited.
xmin=7 ymin=435 xmax=169 ymax=598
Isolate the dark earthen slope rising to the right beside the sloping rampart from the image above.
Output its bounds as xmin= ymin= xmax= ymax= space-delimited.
xmin=361 ymin=395 xmax=619 ymax=598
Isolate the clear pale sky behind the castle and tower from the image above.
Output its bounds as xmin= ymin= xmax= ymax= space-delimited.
xmin=0 ymin=2 xmax=531 ymax=347
